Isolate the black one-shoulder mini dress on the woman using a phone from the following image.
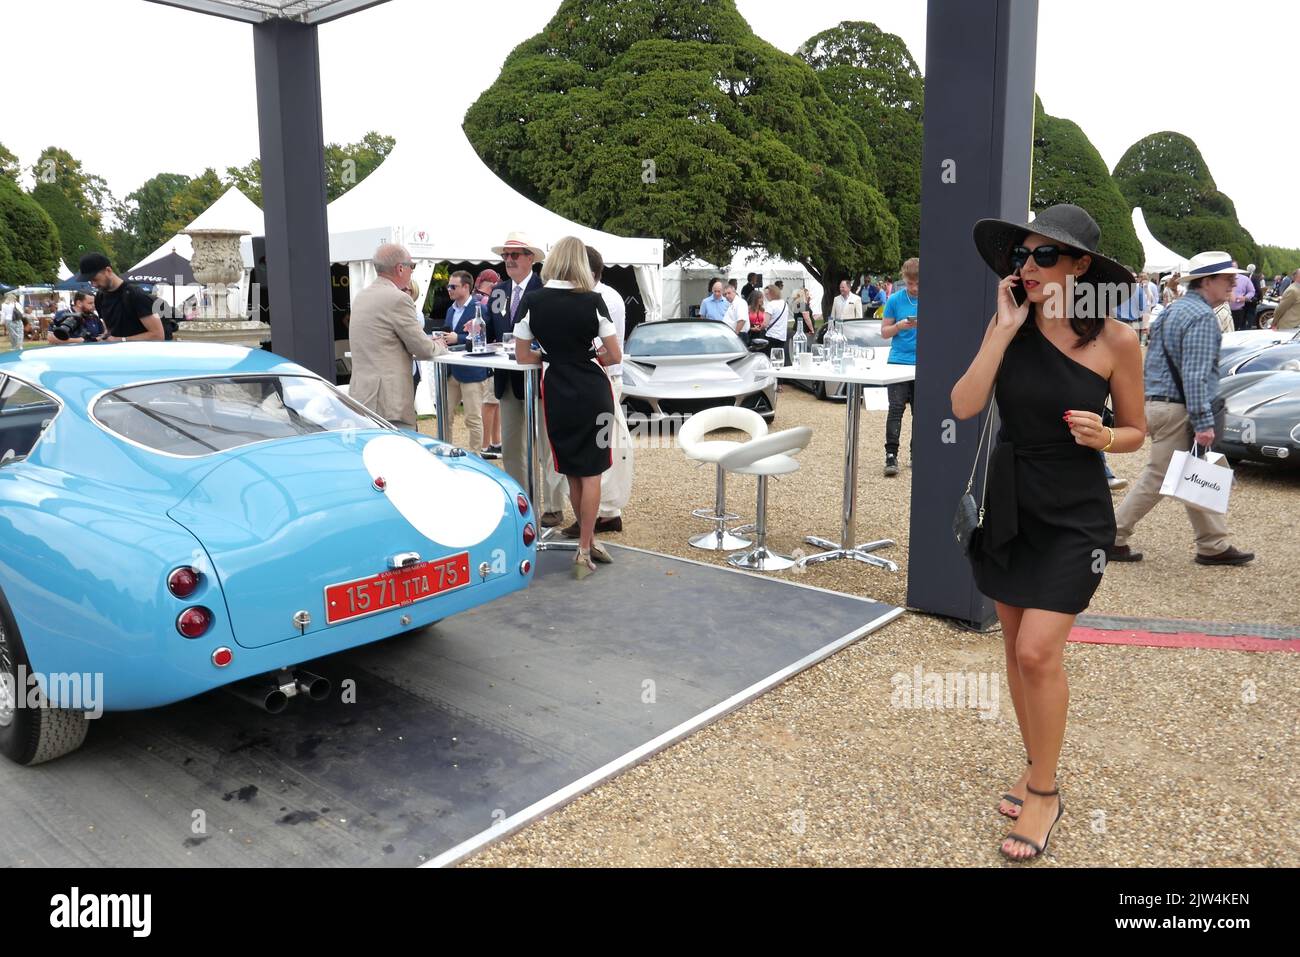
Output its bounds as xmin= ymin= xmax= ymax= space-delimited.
xmin=970 ymin=315 xmax=1115 ymax=615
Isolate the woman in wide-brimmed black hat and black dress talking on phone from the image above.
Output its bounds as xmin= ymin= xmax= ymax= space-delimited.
xmin=952 ymin=205 xmax=1147 ymax=861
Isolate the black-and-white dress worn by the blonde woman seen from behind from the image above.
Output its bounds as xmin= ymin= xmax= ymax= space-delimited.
xmin=515 ymin=280 xmax=615 ymax=477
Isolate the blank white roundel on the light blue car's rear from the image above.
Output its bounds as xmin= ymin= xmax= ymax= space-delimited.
xmin=361 ymin=436 xmax=507 ymax=548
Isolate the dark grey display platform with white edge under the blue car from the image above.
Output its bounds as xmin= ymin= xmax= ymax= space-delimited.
xmin=0 ymin=546 xmax=902 ymax=866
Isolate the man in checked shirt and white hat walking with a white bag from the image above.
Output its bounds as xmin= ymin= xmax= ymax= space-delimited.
xmin=1106 ymin=252 xmax=1255 ymax=566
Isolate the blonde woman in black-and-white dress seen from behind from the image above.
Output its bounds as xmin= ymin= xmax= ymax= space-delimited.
xmin=515 ymin=237 xmax=623 ymax=579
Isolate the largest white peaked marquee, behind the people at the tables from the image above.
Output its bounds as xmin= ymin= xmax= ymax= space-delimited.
xmin=329 ymin=130 xmax=663 ymax=320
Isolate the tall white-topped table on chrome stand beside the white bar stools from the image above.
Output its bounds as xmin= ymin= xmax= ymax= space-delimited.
xmin=772 ymin=361 xmax=917 ymax=572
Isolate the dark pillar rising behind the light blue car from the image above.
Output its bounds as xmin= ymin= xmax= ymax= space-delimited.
xmin=252 ymin=20 xmax=334 ymax=382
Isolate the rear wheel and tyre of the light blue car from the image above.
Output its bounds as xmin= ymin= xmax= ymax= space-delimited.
xmin=0 ymin=593 xmax=90 ymax=765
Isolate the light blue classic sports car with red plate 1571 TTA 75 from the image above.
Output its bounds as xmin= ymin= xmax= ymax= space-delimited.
xmin=0 ymin=342 xmax=536 ymax=765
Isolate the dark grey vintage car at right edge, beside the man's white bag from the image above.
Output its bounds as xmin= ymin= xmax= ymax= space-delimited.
xmin=1214 ymin=369 xmax=1300 ymax=465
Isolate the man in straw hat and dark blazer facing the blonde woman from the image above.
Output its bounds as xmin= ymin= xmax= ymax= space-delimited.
xmin=488 ymin=231 xmax=566 ymax=528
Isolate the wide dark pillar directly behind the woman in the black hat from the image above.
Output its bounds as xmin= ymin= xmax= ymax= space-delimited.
xmin=907 ymin=0 xmax=1039 ymax=624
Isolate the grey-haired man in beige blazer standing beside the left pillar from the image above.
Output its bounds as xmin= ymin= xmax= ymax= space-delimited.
xmin=348 ymin=243 xmax=447 ymax=429
